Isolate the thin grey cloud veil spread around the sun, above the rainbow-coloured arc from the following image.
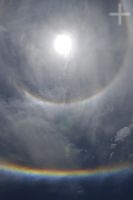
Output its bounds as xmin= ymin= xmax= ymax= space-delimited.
xmin=0 ymin=0 xmax=132 ymax=168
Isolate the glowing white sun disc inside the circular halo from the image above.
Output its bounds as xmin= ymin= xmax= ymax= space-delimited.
xmin=54 ymin=34 xmax=73 ymax=58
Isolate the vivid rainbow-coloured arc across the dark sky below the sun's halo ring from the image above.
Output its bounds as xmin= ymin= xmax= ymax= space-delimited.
xmin=0 ymin=163 xmax=132 ymax=178
